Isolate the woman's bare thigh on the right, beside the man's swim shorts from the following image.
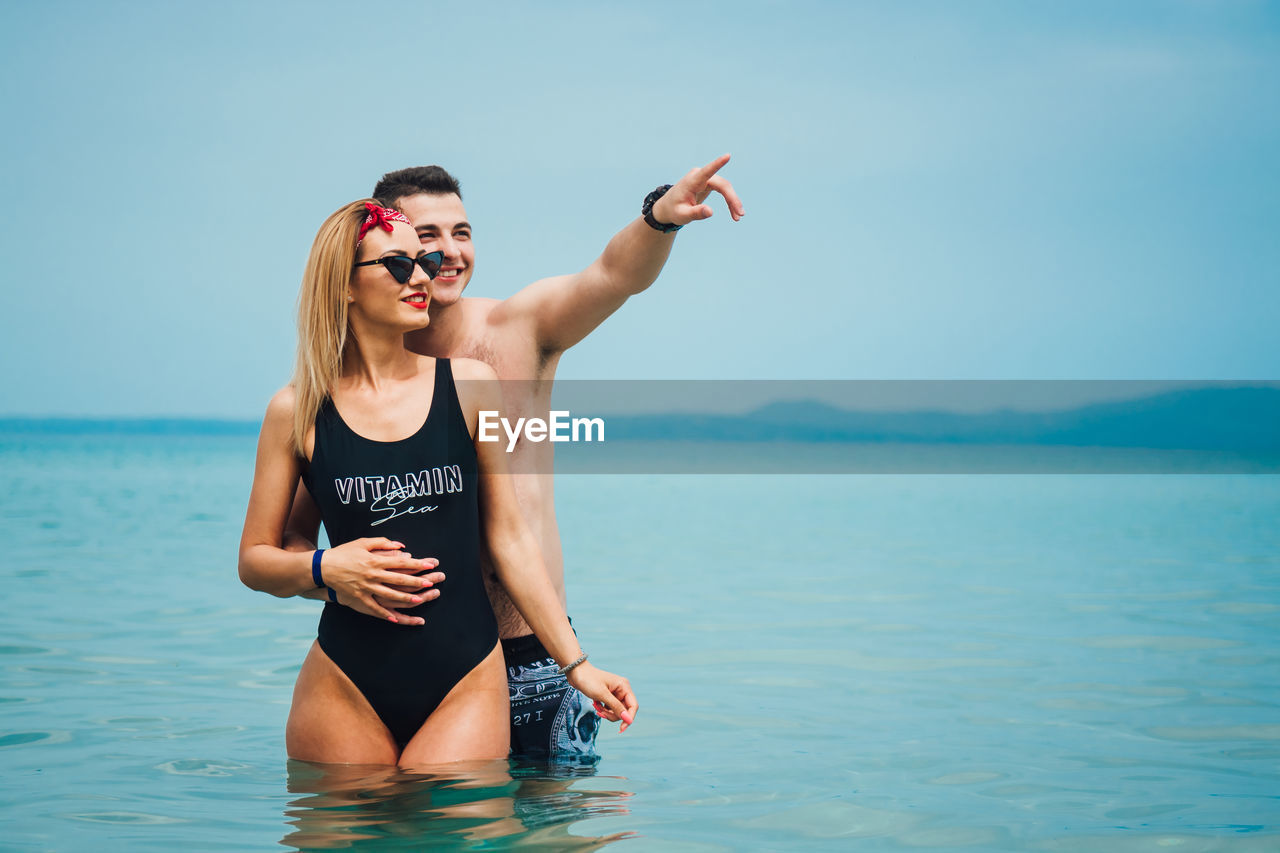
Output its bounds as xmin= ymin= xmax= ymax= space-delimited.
xmin=399 ymin=643 xmax=511 ymax=768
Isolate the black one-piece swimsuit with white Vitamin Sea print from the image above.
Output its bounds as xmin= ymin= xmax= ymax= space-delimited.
xmin=302 ymin=359 xmax=498 ymax=748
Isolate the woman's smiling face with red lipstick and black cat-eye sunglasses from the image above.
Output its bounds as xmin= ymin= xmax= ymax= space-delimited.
xmin=347 ymin=222 xmax=431 ymax=332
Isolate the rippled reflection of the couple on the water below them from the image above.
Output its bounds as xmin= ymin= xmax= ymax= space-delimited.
xmin=280 ymin=760 xmax=634 ymax=850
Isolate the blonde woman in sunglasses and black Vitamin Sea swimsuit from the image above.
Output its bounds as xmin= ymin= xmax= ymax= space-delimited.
xmin=239 ymin=201 xmax=636 ymax=767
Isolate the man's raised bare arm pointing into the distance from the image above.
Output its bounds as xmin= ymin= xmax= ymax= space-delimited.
xmin=495 ymin=154 xmax=744 ymax=352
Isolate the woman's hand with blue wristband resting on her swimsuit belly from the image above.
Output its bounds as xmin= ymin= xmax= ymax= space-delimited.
xmin=321 ymin=538 xmax=444 ymax=625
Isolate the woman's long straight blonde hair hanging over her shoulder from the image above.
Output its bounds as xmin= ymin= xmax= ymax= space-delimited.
xmin=292 ymin=199 xmax=374 ymax=456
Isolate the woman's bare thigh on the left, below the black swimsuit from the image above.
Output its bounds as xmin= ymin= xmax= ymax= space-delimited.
xmin=284 ymin=643 xmax=398 ymax=765
